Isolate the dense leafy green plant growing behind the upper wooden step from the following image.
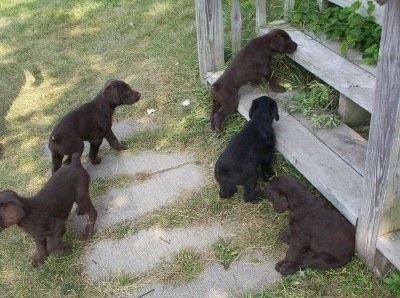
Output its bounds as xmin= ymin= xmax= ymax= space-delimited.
xmin=290 ymin=0 xmax=382 ymax=64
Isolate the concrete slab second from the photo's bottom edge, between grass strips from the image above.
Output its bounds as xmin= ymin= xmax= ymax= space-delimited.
xmin=85 ymin=224 xmax=229 ymax=280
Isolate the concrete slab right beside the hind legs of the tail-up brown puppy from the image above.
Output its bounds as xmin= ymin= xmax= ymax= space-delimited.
xmin=71 ymin=163 xmax=204 ymax=230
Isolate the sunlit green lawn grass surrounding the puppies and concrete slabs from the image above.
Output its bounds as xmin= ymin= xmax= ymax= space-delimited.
xmin=0 ymin=0 xmax=390 ymax=297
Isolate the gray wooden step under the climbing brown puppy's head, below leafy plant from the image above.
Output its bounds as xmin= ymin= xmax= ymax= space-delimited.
xmin=257 ymin=21 xmax=376 ymax=113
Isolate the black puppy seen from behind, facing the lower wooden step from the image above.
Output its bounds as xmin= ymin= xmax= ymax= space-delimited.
xmin=214 ymin=96 xmax=279 ymax=202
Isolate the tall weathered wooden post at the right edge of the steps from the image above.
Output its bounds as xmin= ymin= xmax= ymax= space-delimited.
xmin=357 ymin=0 xmax=400 ymax=270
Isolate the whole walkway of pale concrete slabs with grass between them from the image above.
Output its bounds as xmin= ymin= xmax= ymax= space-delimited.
xmin=46 ymin=120 xmax=280 ymax=297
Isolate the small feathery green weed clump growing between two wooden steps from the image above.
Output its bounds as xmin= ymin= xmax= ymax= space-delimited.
xmin=288 ymin=81 xmax=339 ymax=128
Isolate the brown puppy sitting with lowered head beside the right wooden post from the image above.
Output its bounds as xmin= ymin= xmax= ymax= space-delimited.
xmin=264 ymin=175 xmax=355 ymax=275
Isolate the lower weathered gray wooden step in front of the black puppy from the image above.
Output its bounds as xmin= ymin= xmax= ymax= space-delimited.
xmin=207 ymin=72 xmax=366 ymax=225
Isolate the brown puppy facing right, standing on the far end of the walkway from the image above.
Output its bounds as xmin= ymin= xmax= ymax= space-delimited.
xmin=49 ymin=80 xmax=141 ymax=173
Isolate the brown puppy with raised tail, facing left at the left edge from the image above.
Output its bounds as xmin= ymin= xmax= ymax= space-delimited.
xmin=0 ymin=153 xmax=97 ymax=267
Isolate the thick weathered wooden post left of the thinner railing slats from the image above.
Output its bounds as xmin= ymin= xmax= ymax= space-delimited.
xmin=195 ymin=0 xmax=224 ymax=82
